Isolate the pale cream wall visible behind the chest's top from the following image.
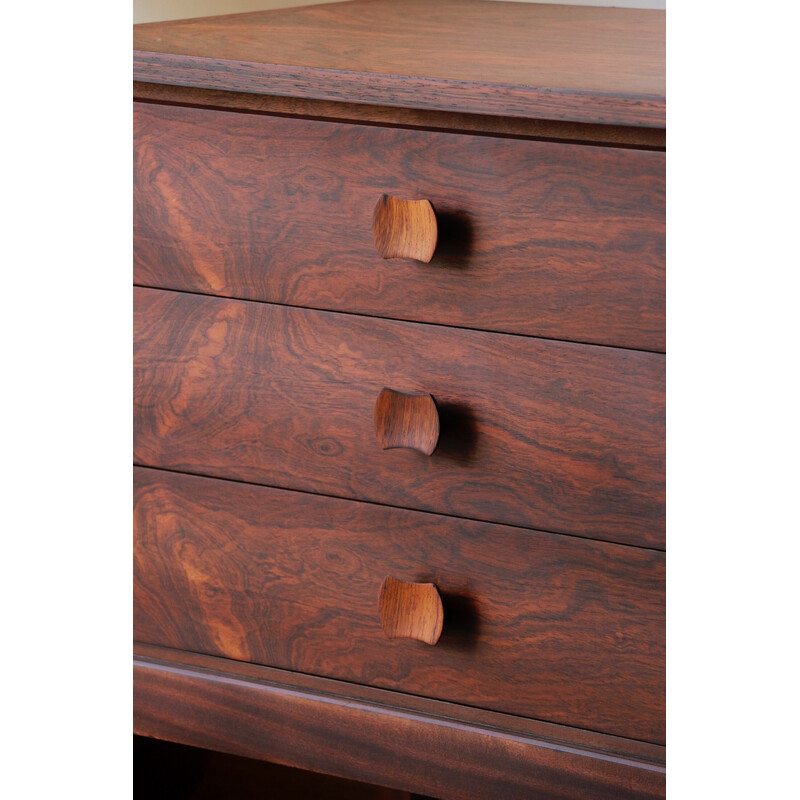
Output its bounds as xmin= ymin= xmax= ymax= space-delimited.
xmin=133 ymin=0 xmax=666 ymax=23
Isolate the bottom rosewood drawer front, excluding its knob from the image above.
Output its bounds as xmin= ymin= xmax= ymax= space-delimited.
xmin=134 ymin=468 xmax=664 ymax=742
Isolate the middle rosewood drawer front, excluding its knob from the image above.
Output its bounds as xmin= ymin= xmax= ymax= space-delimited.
xmin=134 ymin=288 xmax=665 ymax=547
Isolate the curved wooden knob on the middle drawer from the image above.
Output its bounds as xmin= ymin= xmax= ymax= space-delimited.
xmin=374 ymin=388 xmax=439 ymax=456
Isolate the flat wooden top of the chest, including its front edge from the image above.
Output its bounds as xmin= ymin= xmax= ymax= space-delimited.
xmin=134 ymin=0 xmax=665 ymax=128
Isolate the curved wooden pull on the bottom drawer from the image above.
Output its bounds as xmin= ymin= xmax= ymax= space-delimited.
xmin=378 ymin=577 xmax=444 ymax=644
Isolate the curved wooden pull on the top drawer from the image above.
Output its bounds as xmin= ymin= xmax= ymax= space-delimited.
xmin=372 ymin=194 xmax=438 ymax=264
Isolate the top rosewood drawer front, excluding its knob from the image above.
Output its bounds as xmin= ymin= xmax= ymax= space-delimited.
xmin=134 ymin=103 xmax=665 ymax=351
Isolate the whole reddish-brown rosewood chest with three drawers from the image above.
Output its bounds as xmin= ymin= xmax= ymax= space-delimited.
xmin=134 ymin=0 xmax=665 ymax=798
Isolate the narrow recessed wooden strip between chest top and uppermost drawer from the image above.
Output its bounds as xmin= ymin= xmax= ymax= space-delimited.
xmin=133 ymin=81 xmax=667 ymax=150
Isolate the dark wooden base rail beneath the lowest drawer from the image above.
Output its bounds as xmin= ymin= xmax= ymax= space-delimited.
xmin=134 ymin=654 xmax=665 ymax=800
